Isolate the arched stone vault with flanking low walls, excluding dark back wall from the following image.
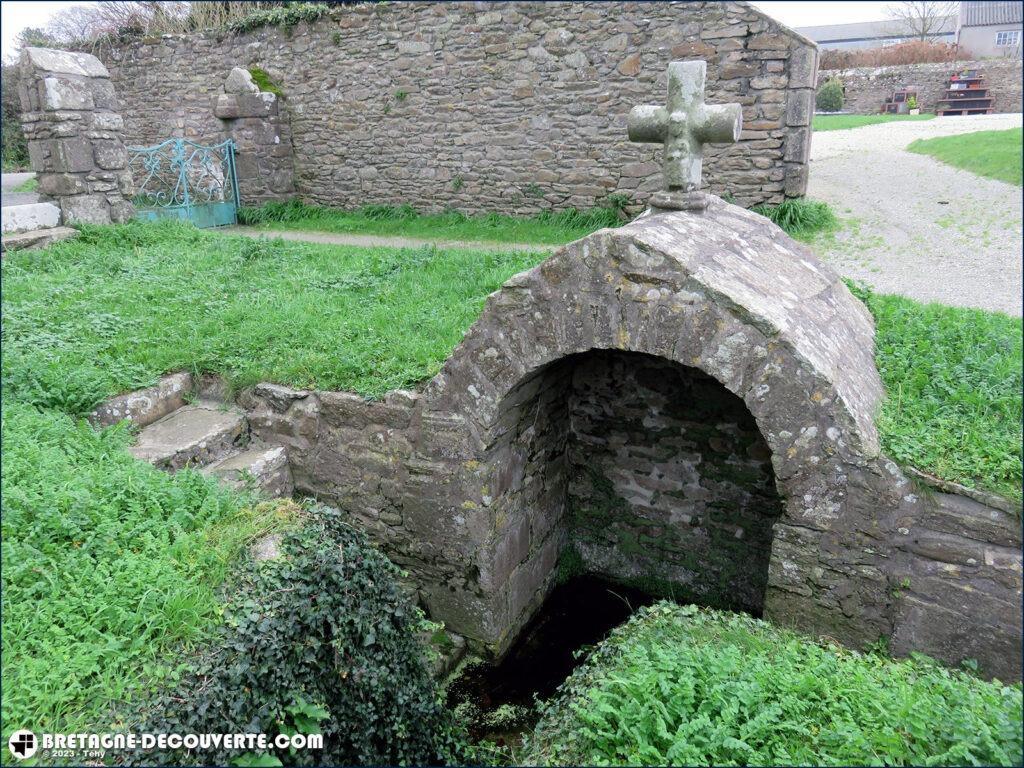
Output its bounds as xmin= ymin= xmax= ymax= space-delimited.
xmin=246 ymin=199 xmax=1021 ymax=676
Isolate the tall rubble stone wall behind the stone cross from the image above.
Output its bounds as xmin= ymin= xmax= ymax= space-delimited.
xmin=104 ymin=2 xmax=817 ymax=212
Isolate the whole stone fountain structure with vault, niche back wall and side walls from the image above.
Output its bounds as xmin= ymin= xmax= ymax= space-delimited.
xmin=237 ymin=200 xmax=1021 ymax=679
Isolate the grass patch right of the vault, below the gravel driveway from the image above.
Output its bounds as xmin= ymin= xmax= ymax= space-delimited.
xmin=855 ymin=289 xmax=1024 ymax=500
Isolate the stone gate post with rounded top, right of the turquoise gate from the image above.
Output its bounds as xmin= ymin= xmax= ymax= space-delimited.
xmin=213 ymin=67 xmax=295 ymax=205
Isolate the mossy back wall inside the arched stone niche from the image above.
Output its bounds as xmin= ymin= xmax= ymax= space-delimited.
xmin=565 ymin=351 xmax=782 ymax=615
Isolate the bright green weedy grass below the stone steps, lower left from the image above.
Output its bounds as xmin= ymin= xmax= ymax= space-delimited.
xmin=0 ymin=399 xmax=299 ymax=738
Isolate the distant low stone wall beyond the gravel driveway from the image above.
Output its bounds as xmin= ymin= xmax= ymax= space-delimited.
xmin=818 ymin=59 xmax=1021 ymax=115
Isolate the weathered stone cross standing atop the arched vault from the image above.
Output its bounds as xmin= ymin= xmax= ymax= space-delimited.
xmin=627 ymin=60 xmax=743 ymax=208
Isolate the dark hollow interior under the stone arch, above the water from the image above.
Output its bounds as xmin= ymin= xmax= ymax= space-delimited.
xmin=490 ymin=349 xmax=782 ymax=626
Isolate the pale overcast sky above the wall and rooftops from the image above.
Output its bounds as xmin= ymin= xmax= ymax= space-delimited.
xmin=0 ymin=0 xmax=905 ymax=59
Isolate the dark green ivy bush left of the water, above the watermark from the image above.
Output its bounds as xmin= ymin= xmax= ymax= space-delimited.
xmin=133 ymin=509 xmax=456 ymax=765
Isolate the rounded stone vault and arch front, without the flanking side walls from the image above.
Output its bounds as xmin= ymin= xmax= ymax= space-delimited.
xmin=425 ymin=201 xmax=899 ymax=646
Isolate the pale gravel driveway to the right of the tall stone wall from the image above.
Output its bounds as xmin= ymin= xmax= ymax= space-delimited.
xmin=808 ymin=115 xmax=1024 ymax=315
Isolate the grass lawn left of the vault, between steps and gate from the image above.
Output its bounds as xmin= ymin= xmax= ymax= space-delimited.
xmin=2 ymin=222 xmax=544 ymax=405
